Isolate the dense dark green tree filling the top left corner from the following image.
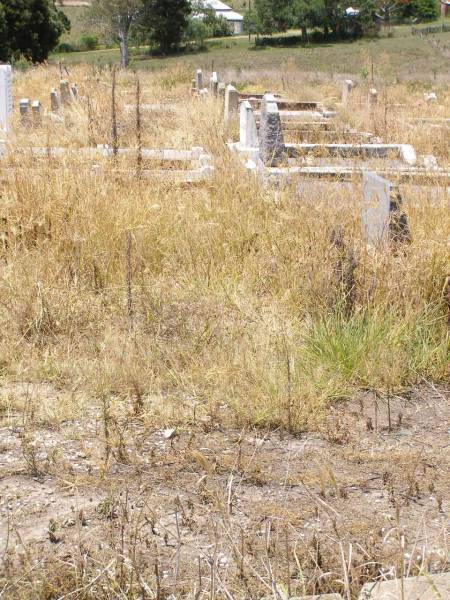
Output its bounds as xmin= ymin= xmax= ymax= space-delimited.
xmin=0 ymin=0 xmax=70 ymax=62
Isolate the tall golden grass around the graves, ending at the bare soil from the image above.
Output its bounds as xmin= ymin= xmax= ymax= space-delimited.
xmin=0 ymin=63 xmax=450 ymax=431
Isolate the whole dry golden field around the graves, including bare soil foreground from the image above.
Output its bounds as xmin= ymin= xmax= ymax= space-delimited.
xmin=0 ymin=63 xmax=450 ymax=600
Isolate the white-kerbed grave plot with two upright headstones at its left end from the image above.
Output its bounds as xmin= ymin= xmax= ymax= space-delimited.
xmin=229 ymin=94 xmax=450 ymax=181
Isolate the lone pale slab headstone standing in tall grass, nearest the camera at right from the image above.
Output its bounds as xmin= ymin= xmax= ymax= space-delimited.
xmin=361 ymin=171 xmax=410 ymax=248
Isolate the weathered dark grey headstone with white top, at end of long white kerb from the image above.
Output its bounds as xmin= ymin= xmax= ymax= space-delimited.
xmin=259 ymin=94 xmax=286 ymax=167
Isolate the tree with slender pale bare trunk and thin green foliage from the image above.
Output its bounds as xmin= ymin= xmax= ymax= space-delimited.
xmin=87 ymin=0 xmax=143 ymax=68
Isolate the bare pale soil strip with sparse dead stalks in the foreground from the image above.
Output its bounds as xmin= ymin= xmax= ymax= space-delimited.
xmin=0 ymin=384 xmax=450 ymax=591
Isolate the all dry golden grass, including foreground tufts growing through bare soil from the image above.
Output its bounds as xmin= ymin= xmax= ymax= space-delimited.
xmin=0 ymin=67 xmax=450 ymax=599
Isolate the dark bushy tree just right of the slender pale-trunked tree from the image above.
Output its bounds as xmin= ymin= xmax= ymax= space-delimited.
xmin=141 ymin=0 xmax=191 ymax=54
